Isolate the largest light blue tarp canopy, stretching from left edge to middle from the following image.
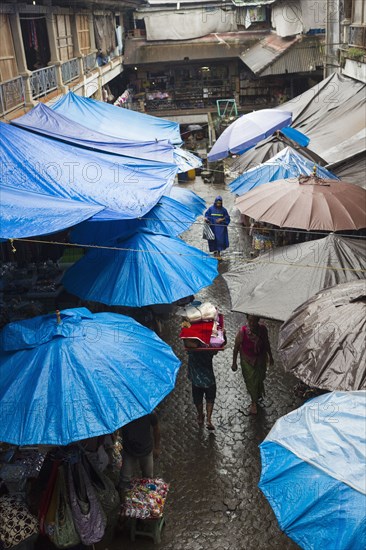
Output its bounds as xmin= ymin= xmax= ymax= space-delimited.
xmin=0 ymin=123 xmax=177 ymax=219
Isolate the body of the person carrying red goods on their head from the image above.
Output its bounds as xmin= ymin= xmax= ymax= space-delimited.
xmin=188 ymin=331 xmax=227 ymax=430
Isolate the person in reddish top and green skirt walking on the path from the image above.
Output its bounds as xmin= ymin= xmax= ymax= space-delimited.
xmin=231 ymin=315 xmax=273 ymax=414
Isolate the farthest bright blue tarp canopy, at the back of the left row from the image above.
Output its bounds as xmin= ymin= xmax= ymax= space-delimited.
xmin=51 ymin=92 xmax=182 ymax=145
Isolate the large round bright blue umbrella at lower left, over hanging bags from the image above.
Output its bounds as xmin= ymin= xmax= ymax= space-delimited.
xmin=0 ymin=308 xmax=180 ymax=445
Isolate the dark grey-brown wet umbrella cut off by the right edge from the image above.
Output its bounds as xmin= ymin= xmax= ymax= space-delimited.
xmin=279 ymin=281 xmax=366 ymax=391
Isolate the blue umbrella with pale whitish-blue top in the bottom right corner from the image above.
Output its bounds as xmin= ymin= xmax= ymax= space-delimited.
xmin=259 ymin=391 xmax=366 ymax=550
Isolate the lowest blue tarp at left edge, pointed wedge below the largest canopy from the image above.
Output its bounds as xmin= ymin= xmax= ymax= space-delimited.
xmin=0 ymin=185 xmax=103 ymax=239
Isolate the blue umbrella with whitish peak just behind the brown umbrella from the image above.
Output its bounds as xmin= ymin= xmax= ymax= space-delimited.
xmin=229 ymin=147 xmax=338 ymax=195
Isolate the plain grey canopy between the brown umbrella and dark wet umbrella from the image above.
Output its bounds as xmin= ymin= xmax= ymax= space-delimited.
xmin=223 ymin=234 xmax=366 ymax=321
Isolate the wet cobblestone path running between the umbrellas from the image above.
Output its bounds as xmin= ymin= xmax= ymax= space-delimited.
xmin=108 ymin=178 xmax=301 ymax=550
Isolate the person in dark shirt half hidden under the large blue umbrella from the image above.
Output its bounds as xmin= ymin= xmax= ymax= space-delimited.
xmin=119 ymin=412 xmax=160 ymax=490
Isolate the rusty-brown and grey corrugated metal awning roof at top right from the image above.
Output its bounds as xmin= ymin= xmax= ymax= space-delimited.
xmin=240 ymin=34 xmax=323 ymax=76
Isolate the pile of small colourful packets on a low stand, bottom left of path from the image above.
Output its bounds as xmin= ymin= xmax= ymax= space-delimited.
xmin=122 ymin=479 xmax=169 ymax=519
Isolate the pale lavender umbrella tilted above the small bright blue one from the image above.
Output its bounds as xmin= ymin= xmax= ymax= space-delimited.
xmin=207 ymin=109 xmax=292 ymax=162
